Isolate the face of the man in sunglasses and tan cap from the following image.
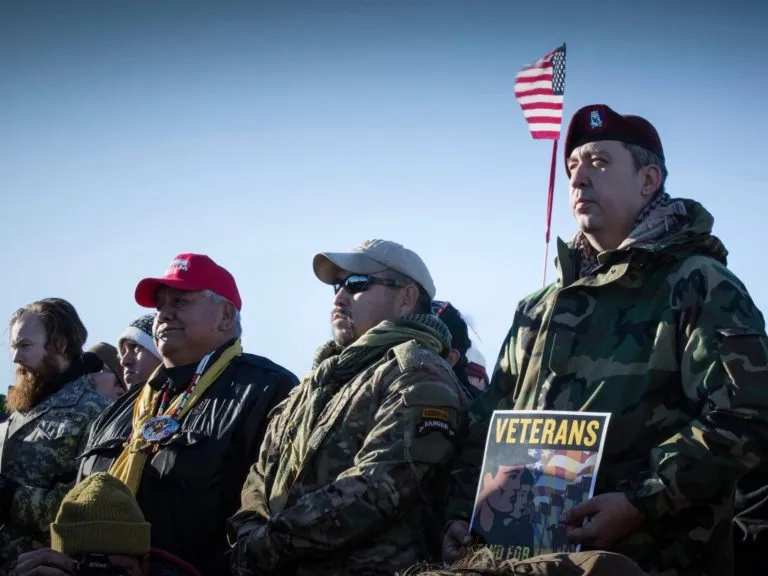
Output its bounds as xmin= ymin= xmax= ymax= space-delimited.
xmin=331 ymin=271 xmax=401 ymax=347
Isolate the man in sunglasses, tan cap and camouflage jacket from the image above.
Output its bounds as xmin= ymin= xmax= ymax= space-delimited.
xmin=231 ymin=240 xmax=468 ymax=576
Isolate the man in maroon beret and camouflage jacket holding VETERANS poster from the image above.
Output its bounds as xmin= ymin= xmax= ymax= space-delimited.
xmin=444 ymin=104 xmax=768 ymax=576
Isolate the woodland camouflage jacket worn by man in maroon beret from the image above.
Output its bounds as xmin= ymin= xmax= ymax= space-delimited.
xmin=449 ymin=200 xmax=768 ymax=576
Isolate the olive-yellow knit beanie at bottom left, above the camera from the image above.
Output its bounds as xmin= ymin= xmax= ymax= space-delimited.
xmin=51 ymin=472 xmax=150 ymax=558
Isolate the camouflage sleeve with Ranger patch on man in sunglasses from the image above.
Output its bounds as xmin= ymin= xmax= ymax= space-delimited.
xmin=241 ymin=371 xmax=463 ymax=572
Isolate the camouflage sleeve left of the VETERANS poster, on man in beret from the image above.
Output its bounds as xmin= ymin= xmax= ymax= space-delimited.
xmin=446 ymin=314 xmax=519 ymax=524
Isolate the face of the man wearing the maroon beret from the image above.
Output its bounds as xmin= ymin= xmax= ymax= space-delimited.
xmin=568 ymin=140 xmax=647 ymax=245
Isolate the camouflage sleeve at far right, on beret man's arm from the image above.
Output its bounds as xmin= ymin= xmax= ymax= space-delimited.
xmin=625 ymin=257 xmax=768 ymax=520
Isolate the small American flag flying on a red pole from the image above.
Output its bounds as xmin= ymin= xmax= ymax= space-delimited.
xmin=515 ymin=44 xmax=565 ymax=140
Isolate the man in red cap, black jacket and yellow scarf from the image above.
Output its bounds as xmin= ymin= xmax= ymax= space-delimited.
xmin=78 ymin=254 xmax=297 ymax=576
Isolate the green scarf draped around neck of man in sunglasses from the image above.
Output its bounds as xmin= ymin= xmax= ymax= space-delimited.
xmin=269 ymin=314 xmax=451 ymax=514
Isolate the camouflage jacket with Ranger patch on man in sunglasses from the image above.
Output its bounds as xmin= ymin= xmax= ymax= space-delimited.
xmin=225 ymin=316 xmax=469 ymax=576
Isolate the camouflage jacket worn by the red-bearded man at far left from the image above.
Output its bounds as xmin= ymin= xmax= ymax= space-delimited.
xmin=0 ymin=375 xmax=111 ymax=575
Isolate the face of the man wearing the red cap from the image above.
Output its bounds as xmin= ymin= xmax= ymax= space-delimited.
xmin=153 ymin=287 xmax=226 ymax=366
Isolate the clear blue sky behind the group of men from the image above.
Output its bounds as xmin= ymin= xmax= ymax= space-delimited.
xmin=0 ymin=0 xmax=768 ymax=390
